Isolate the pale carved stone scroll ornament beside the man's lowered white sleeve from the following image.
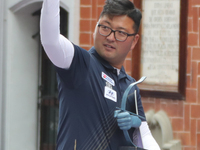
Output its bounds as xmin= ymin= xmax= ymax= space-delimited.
xmin=145 ymin=110 xmax=181 ymax=150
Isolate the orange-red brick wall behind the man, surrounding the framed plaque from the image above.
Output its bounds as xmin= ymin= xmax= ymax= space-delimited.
xmin=80 ymin=0 xmax=200 ymax=150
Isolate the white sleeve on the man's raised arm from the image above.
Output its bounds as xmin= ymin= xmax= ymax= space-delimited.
xmin=40 ymin=0 xmax=74 ymax=69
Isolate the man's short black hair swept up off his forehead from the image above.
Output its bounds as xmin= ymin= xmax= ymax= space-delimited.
xmin=100 ymin=0 xmax=142 ymax=33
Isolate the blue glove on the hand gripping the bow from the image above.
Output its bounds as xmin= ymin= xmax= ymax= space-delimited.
xmin=114 ymin=110 xmax=141 ymax=130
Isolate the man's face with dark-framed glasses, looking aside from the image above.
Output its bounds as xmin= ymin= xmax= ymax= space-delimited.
xmin=94 ymin=15 xmax=139 ymax=69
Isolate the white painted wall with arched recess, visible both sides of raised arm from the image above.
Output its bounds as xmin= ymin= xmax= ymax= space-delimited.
xmin=0 ymin=0 xmax=80 ymax=150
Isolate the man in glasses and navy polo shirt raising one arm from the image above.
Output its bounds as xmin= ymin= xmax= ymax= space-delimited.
xmin=40 ymin=0 xmax=159 ymax=150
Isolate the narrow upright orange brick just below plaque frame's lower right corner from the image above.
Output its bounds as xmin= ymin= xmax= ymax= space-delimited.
xmin=184 ymin=105 xmax=190 ymax=131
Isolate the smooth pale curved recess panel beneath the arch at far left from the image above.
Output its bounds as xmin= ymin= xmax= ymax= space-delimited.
xmin=5 ymin=12 xmax=38 ymax=150
